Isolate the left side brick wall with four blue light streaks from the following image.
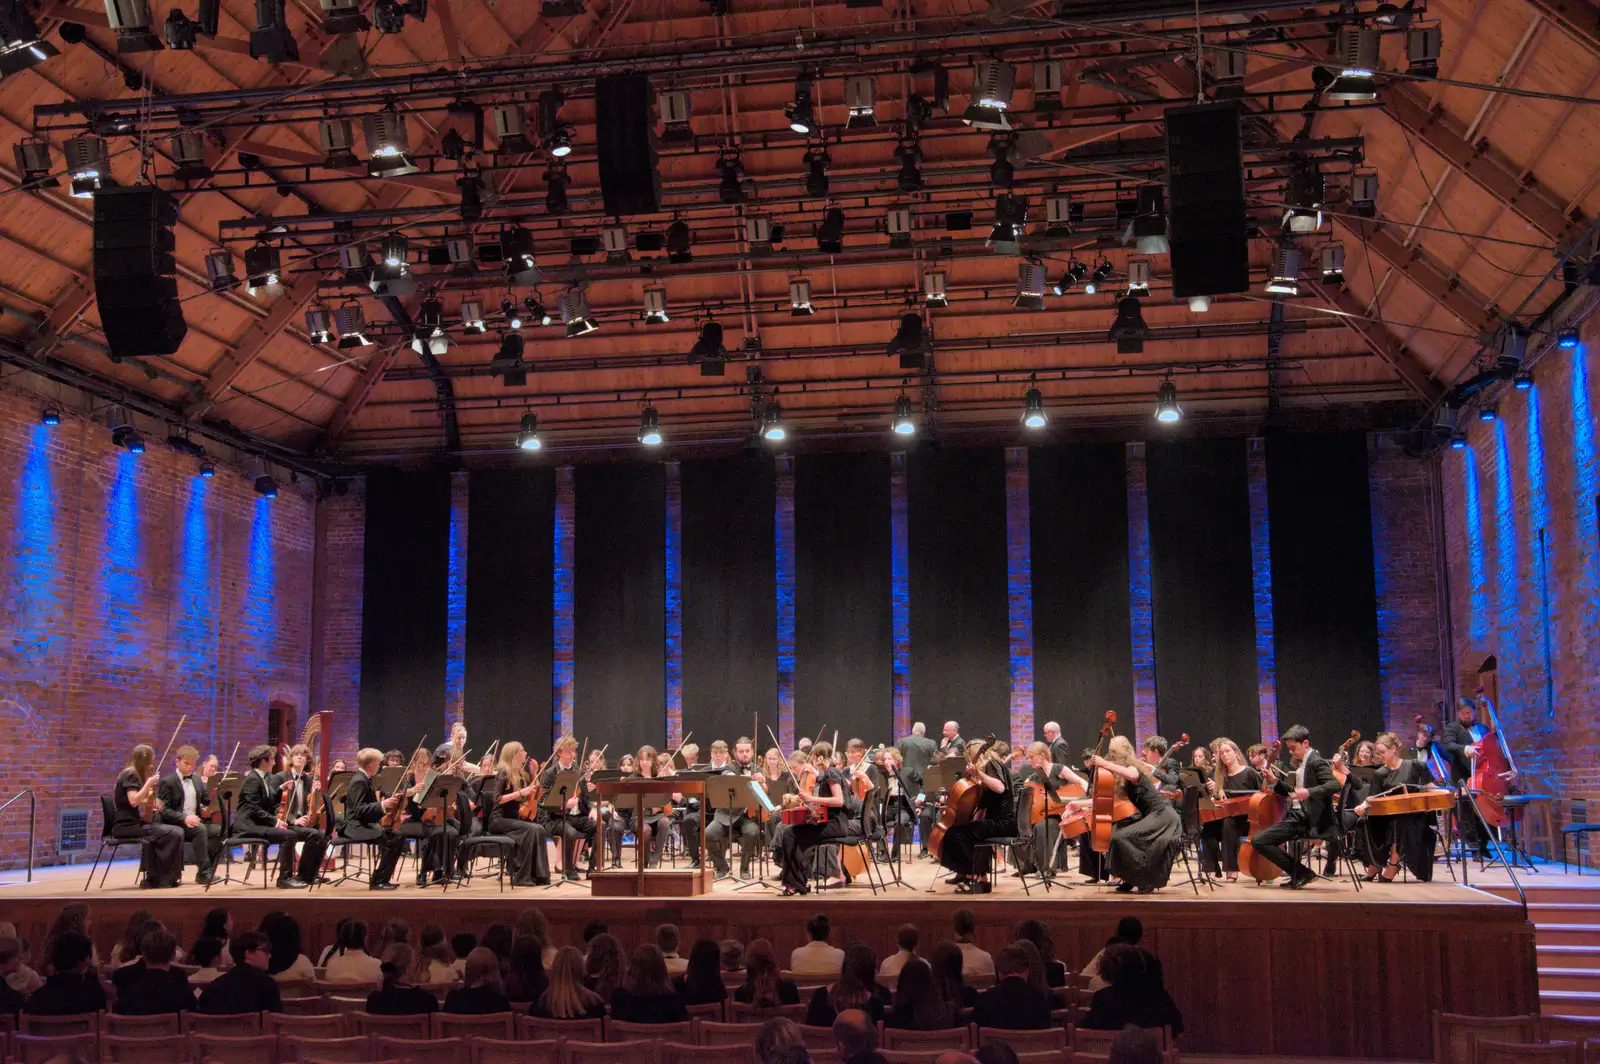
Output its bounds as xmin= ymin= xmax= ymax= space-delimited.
xmin=0 ymin=389 xmax=318 ymax=867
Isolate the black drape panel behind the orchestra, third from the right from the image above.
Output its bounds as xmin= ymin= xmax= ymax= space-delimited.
xmin=1027 ymin=443 xmax=1133 ymax=744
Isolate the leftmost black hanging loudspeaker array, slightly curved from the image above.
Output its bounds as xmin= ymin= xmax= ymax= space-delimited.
xmin=94 ymin=186 xmax=189 ymax=362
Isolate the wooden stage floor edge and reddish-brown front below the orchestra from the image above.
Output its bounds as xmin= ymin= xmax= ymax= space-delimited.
xmin=0 ymin=854 xmax=1539 ymax=1059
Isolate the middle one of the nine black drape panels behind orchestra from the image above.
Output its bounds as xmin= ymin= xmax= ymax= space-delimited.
xmin=793 ymin=453 xmax=894 ymax=742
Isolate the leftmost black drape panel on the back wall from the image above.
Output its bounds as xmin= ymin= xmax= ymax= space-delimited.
xmin=360 ymin=469 xmax=450 ymax=750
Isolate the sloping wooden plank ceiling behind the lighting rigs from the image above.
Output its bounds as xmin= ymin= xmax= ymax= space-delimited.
xmin=0 ymin=0 xmax=1600 ymax=464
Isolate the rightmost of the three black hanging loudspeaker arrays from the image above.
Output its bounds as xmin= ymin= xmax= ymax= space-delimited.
xmin=1165 ymin=104 xmax=1250 ymax=299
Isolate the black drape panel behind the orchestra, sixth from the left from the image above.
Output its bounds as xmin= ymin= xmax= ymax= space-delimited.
xmin=906 ymin=448 xmax=1011 ymax=739
